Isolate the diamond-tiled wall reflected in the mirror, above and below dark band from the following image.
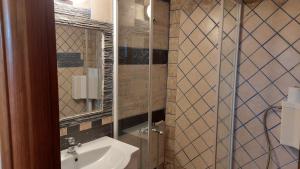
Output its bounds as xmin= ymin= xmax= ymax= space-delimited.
xmin=56 ymin=25 xmax=86 ymax=118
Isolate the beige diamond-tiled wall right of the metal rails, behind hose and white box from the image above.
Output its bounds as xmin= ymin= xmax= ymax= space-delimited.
xmin=234 ymin=0 xmax=300 ymax=169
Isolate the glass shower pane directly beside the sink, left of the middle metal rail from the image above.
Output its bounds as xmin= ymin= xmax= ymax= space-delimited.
xmin=117 ymin=0 xmax=151 ymax=169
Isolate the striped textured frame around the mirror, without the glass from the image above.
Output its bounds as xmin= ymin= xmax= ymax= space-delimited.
xmin=54 ymin=2 xmax=113 ymax=128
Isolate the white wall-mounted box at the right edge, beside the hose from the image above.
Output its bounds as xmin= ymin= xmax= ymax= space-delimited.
xmin=280 ymin=87 xmax=300 ymax=149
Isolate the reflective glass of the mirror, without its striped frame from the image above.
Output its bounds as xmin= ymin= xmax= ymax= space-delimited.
xmin=56 ymin=24 xmax=103 ymax=119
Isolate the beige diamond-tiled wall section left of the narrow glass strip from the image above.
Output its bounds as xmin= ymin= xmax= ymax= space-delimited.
xmin=175 ymin=0 xmax=220 ymax=169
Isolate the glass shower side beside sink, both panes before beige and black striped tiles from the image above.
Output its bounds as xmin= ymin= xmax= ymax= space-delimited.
xmin=114 ymin=0 xmax=169 ymax=169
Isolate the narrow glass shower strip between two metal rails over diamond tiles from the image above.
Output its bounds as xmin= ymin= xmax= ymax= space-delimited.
xmin=216 ymin=0 xmax=241 ymax=169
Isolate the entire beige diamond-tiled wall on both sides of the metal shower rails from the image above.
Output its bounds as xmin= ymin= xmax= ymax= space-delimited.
xmin=166 ymin=0 xmax=300 ymax=169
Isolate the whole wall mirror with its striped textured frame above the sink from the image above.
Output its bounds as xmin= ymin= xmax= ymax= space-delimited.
xmin=54 ymin=2 xmax=113 ymax=128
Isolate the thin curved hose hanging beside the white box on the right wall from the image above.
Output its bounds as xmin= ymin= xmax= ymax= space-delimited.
xmin=264 ymin=106 xmax=281 ymax=169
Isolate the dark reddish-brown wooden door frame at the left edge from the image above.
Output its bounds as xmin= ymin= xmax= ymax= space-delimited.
xmin=0 ymin=0 xmax=60 ymax=169
